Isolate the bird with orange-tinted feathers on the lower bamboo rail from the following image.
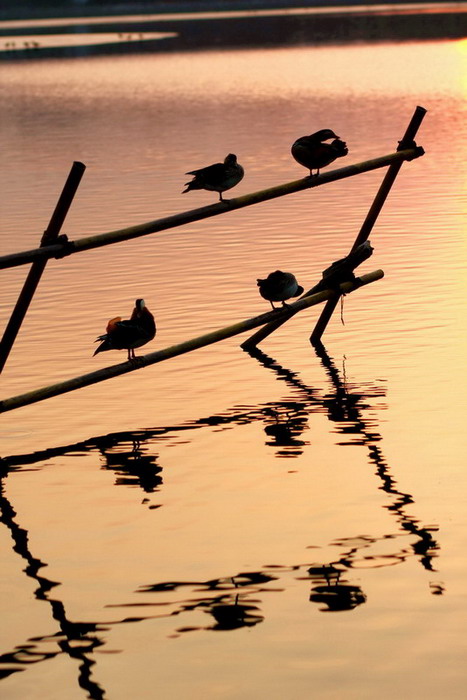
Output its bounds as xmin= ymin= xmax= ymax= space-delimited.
xmin=94 ymin=299 xmax=156 ymax=360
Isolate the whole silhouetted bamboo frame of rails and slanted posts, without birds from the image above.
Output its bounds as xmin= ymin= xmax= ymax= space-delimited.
xmin=0 ymin=107 xmax=426 ymax=413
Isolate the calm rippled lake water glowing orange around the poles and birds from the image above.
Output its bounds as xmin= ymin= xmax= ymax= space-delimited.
xmin=0 ymin=6 xmax=467 ymax=700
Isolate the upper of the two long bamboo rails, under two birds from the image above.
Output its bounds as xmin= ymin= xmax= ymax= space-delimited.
xmin=0 ymin=147 xmax=423 ymax=269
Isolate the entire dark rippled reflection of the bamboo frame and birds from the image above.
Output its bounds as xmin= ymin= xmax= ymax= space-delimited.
xmin=0 ymin=346 xmax=444 ymax=688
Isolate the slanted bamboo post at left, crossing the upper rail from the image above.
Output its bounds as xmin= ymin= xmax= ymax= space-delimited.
xmin=0 ymin=161 xmax=86 ymax=374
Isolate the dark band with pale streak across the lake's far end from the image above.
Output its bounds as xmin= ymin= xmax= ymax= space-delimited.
xmin=0 ymin=3 xmax=467 ymax=59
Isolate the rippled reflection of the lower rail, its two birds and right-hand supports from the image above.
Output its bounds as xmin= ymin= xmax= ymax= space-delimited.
xmin=0 ymin=345 xmax=439 ymax=570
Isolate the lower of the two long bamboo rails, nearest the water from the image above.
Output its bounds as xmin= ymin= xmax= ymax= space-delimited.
xmin=0 ymin=270 xmax=384 ymax=413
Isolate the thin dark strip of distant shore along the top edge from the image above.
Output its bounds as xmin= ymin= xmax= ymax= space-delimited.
xmin=0 ymin=0 xmax=467 ymax=21
